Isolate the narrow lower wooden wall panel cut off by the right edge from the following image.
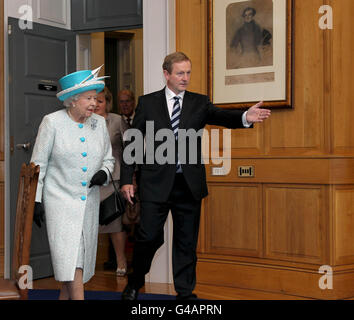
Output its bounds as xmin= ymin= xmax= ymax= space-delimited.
xmin=334 ymin=185 xmax=354 ymax=264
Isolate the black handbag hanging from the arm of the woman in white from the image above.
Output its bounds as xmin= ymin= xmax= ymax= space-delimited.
xmin=99 ymin=168 xmax=126 ymax=225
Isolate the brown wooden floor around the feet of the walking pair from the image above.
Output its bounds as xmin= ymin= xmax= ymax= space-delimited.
xmin=33 ymin=266 xmax=306 ymax=300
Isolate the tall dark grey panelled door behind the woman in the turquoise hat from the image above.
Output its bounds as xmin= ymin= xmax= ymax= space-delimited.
xmin=9 ymin=18 xmax=76 ymax=279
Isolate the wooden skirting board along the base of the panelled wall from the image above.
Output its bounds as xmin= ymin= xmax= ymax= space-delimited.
xmin=197 ymin=259 xmax=354 ymax=299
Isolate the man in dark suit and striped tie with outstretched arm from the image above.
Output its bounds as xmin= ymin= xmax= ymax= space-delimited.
xmin=121 ymin=52 xmax=270 ymax=300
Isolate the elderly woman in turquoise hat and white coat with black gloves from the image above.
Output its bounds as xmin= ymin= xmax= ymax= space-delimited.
xmin=31 ymin=68 xmax=114 ymax=300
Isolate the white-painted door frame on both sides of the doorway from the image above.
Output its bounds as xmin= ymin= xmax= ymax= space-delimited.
xmin=1 ymin=0 xmax=176 ymax=283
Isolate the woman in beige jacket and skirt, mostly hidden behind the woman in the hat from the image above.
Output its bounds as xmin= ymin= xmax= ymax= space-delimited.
xmin=95 ymin=87 xmax=128 ymax=276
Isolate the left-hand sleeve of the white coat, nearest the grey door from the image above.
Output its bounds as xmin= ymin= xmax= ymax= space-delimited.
xmin=31 ymin=116 xmax=55 ymax=202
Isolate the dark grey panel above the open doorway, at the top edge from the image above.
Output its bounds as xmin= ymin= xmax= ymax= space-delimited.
xmin=71 ymin=0 xmax=143 ymax=31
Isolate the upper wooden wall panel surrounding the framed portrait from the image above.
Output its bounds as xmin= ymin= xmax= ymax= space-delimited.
xmin=176 ymin=0 xmax=329 ymax=157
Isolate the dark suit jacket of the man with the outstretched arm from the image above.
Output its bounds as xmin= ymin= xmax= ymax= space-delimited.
xmin=121 ymin=88 xmax=248 ymax=202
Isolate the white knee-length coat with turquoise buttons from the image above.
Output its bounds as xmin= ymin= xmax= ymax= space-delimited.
xmin=31 ymin=109 xmax=114 ymax=283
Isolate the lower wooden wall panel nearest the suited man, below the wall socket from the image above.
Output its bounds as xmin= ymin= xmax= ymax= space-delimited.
xmin=205 ymin=184 xmax=262 ymax=256
